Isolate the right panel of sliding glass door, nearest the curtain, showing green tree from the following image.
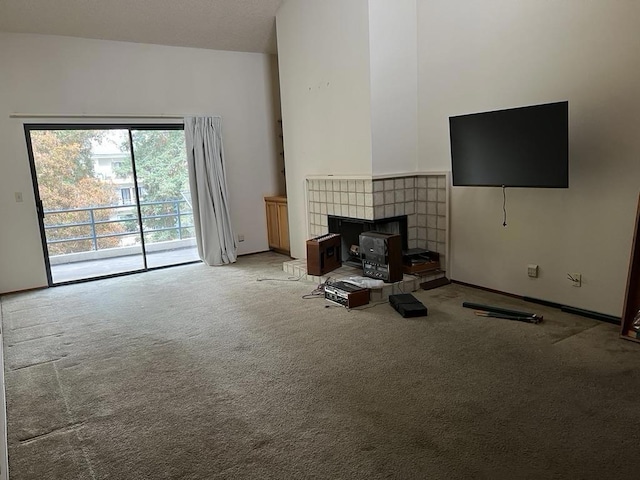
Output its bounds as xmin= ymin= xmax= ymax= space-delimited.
xmin=131 ymin=128 xmax=200 ymax=268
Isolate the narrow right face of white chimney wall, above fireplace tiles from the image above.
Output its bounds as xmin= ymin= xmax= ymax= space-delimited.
xmin=369 ymin=0 xmax=418 ymax=175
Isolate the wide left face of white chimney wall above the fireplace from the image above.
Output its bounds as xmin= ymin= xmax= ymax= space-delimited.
xmin=276 ymin=0 xmax=372 ymax=258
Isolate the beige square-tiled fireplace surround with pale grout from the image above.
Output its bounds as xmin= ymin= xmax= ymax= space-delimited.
xmin=306 ymin=174 xmax=448 ymax=270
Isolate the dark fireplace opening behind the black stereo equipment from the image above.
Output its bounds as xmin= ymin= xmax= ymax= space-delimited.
xmin=327 ymin=215 xmax=408 ymax=267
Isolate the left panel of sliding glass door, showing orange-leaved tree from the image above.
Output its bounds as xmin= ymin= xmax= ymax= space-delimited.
xmin=27 ymin=127 xmax=145 ymax=285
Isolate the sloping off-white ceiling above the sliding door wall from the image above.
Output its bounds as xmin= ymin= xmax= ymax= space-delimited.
xmin=0 ymin=0 xmax=282 ymax=53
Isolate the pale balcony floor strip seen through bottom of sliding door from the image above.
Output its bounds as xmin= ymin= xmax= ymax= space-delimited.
xmin=51 ymin=246 xmax=200 ymax=284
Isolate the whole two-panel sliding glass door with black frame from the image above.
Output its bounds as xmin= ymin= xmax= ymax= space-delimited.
xmin=25 ymin=125 xmax=199 ymax=285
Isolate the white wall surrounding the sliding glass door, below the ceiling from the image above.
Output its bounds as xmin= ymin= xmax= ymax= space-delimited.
xmin=0 ymin=33 xmax=278 ymax=292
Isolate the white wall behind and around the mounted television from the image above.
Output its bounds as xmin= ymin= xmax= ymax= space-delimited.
xmin=418 ymin=0 xmax=640 ymax=316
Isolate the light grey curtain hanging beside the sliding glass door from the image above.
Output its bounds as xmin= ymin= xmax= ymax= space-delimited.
xmin=184 ymin=117 xmax=238 ymax=265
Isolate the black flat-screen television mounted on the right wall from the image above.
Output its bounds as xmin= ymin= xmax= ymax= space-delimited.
xmin=449 ymin=101 xmax=569 ymax=188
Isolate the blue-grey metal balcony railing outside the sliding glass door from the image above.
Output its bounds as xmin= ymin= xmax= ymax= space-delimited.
xmin=43 ymin=200 xmax=194 ymax=251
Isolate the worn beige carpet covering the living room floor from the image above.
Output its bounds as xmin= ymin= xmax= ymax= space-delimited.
xmin=1 ymin=253 xmax=640 ymax=480
